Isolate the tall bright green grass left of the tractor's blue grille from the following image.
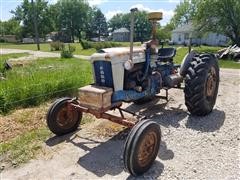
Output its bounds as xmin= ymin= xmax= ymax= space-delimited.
xmin=0 ymin=58 xmax=92 ymax=113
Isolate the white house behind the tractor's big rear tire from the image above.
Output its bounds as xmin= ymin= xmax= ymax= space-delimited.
xmin=172 ymin=23 xmax=229 ymax=46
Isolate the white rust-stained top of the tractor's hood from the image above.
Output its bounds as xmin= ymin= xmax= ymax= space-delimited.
xmin=91 ymin=47 xmax=145 ymax=64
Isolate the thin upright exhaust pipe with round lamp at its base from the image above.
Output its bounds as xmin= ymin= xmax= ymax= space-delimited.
xmin=124 ymin=8 xmax=138 ymax=70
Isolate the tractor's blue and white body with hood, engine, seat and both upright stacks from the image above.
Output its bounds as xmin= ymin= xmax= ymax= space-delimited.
xmin=91 ymin=9 xmax=182 ymax=103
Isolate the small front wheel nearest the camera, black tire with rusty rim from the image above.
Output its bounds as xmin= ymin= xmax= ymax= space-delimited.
xmin=123 ymin=120 xmax=161 ymax=176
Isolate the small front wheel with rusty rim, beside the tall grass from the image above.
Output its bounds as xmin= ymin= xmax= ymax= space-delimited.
xmin=47 ymin=97 xmax=82 ymax=136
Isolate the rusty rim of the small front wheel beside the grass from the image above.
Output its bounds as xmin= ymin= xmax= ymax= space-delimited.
xmin=56 ymin=105 xmax=78 ymax=129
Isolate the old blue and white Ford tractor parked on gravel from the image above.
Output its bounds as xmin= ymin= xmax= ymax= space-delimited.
xmin=47 ymin=8 xmax=219 ymax=176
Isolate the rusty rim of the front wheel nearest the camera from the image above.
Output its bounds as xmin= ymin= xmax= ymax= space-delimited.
xmin=137 ymin=132 xmax=157 ymax=167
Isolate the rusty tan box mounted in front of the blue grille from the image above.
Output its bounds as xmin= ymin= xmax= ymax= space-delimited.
xmin=79 ymin=85 xmax=113 ymax=110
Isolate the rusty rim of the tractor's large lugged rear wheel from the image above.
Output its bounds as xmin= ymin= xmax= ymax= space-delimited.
xmin=206 ymin=67 xmax=217 ymax=98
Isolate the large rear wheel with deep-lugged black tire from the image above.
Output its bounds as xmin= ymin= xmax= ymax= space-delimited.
xmin=184 ymin=54 xmax=219 ymax=116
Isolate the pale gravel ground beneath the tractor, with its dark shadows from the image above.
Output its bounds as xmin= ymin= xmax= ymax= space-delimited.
xmin=2 ymin=69 xmax=240 ymax=180
